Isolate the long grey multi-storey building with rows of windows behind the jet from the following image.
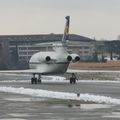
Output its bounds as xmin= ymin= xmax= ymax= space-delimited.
xmin=0 ymin=34 xmax=95 ymax=68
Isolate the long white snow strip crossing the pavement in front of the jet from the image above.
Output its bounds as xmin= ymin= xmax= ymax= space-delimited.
xmin=0 ymin=87 xmax=120 ymax=104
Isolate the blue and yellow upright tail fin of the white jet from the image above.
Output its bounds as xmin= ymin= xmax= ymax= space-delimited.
xmin=62 ymin=16 xmax=70 ymax=43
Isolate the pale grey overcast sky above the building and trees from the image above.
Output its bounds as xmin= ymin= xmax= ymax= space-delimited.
xmin=0 ymin=0 xmax=120 ymax=40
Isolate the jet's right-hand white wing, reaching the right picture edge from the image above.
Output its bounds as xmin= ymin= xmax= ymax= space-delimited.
xmin=67 ymin=69 xmax=120 ymax=73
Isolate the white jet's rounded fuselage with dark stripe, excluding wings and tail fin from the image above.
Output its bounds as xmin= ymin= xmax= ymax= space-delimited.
xmin=29 ymin=44 xmax=72 ymax=74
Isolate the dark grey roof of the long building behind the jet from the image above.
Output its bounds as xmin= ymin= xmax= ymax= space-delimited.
xmin=0 ymin=33 xmax=95 ymax=44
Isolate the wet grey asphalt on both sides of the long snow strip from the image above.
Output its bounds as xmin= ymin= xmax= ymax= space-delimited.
xmin=0 ymin=74 xmax=120 ymax=120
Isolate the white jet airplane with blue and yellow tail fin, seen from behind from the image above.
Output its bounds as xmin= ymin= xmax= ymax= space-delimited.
xmin=0 ymin=16 xmax=80 ymax=84
